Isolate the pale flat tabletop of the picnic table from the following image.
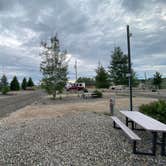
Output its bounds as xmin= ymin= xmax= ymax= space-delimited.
xmin=120 ymin=111 xmax=166 ymax=132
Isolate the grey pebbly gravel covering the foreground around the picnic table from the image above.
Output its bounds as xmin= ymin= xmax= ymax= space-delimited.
xmin=0 ymin=112 xmax=166 ymax=166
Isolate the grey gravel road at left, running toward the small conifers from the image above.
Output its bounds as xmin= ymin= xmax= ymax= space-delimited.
xmin=0 ymin=90 xmax=44 ymax=118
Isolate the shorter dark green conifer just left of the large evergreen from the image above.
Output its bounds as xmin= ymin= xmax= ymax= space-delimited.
xmin=95 ymin=64 xmax=110 ymax=88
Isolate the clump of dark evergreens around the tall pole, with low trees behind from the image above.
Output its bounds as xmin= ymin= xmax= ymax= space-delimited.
xmin=77 ymin=47 xmax=138 ymax=88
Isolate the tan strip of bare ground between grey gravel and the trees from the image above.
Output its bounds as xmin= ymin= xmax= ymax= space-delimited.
xmin=4 ymin=93 xmax=156 ymax=123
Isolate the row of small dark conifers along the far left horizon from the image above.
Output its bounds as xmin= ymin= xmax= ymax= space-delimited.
xmin=0 ymin=75 xmax=34 ymax=94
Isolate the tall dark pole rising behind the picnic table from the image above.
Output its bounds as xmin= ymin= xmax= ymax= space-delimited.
xmin=127 ymin=25 xmax=133 ymax=111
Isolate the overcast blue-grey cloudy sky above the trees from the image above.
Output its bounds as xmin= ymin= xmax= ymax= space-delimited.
xmin=0 ymin=0 xmax=166 ymax=82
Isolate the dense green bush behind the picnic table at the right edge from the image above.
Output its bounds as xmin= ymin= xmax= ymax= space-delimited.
xmin=139 ymin=100 xmax=166 ymax=123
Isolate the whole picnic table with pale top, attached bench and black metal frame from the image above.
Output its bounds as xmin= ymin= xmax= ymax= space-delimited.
xmin=112 ymin=111 xmax=166 ymax=156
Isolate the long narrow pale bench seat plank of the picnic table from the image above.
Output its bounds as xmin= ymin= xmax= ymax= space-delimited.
xmin=111 ymin=116 xmax=141 ymax=141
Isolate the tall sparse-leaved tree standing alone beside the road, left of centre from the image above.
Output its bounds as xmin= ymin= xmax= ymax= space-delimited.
xmin=40 ymin=36 xmax=68 ymax=99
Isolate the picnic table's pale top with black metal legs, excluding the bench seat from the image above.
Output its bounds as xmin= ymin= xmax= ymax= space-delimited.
xmin=120 ymin=111 xmax=166 ymax=155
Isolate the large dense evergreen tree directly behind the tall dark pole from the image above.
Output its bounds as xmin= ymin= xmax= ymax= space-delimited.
xmin=108 ymin=47 xmax=138 ymax=86
